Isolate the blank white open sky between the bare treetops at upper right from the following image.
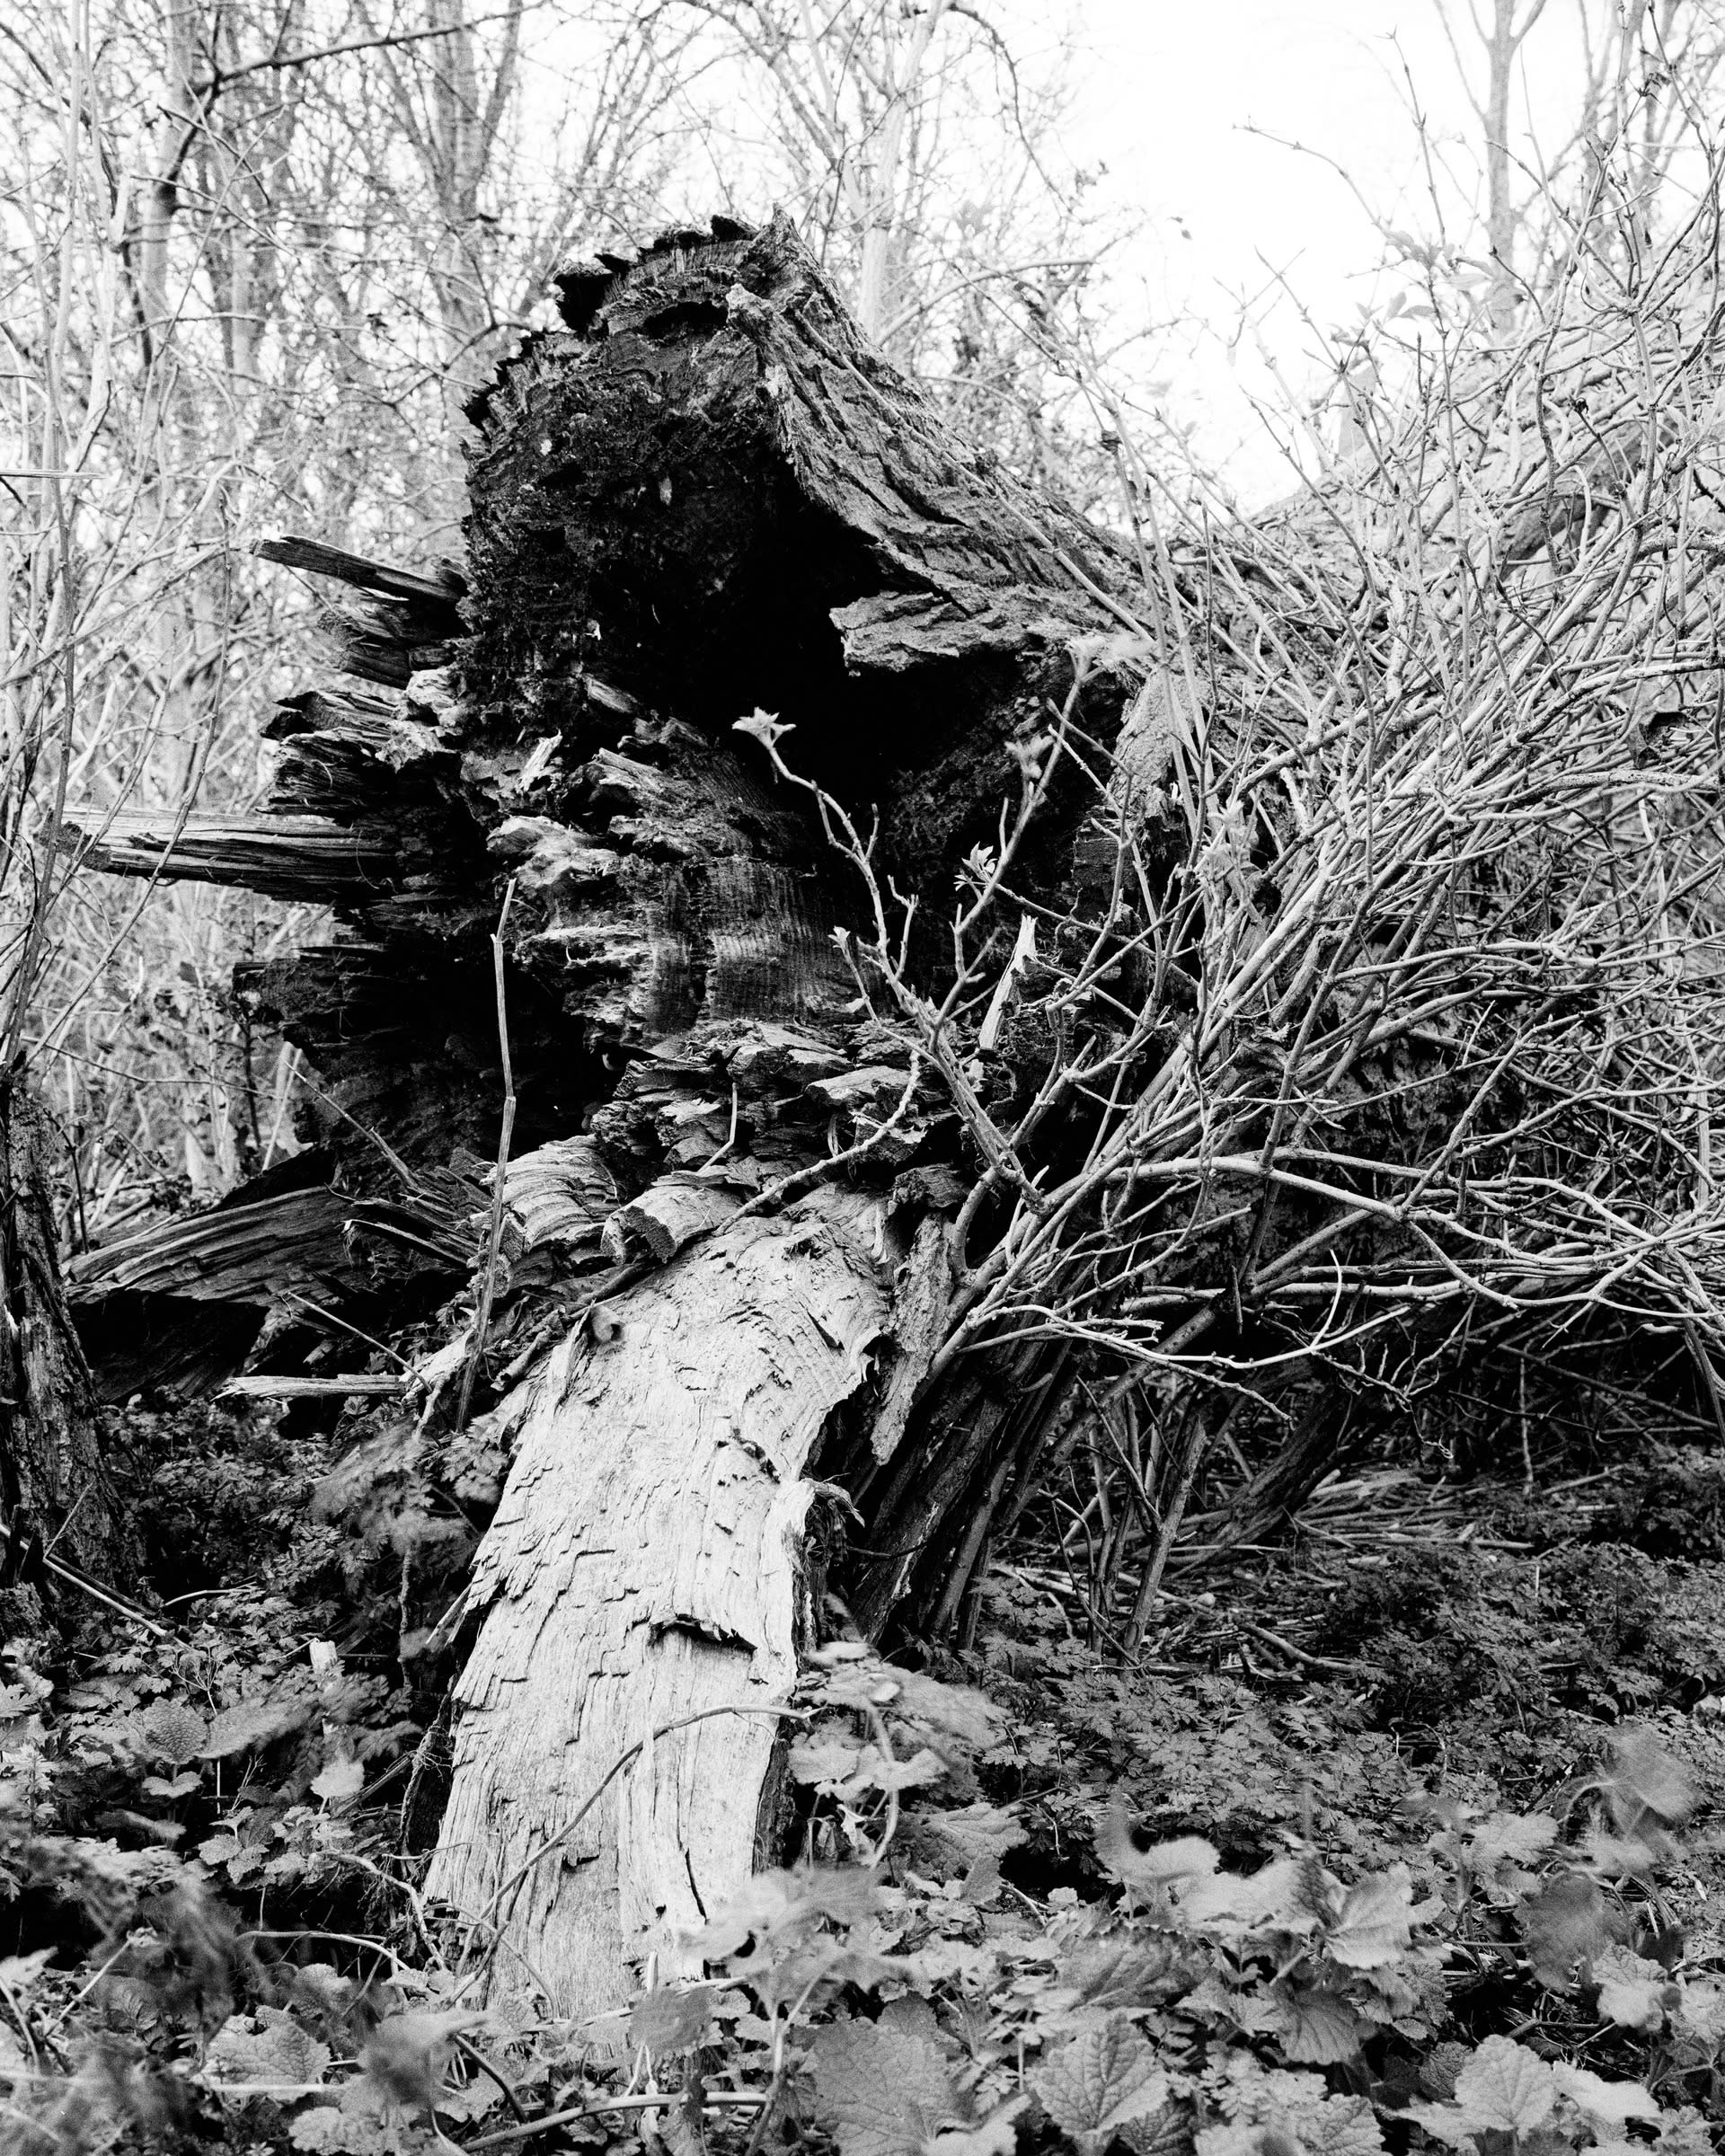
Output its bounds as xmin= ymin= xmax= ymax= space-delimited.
xmin=1069 ymin=0 xmax=1580 ymax=494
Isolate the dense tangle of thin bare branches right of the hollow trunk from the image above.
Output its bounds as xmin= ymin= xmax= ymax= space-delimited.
xmin=823 ymin=185 xmax=1725 ymax=1637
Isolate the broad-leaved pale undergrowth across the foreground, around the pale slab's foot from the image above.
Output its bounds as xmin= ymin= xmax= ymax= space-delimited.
xmin=0 ymin=1604 xmax=1725 ymax=2156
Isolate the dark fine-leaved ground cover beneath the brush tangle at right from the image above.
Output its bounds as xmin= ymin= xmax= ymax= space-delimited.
xmin=961 ymin=1446 xmax=1725 ymax=1897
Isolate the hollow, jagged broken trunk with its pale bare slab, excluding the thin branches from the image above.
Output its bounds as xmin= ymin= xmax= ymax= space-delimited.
xmin=67 ymin=210 xmax=1126 ymax=2014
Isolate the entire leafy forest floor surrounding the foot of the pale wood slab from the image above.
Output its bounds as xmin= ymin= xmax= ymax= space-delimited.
xmin=0 ymin=1408 xmax=1725 ymax=2156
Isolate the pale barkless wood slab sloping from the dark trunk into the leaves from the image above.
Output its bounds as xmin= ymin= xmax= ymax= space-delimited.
xmin=427 ymin=1192 xmax=890 ymax=2016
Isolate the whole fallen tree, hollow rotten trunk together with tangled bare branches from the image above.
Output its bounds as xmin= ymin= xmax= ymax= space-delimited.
xmin=64 ymin=202 xmax=1725 ymax=2011
